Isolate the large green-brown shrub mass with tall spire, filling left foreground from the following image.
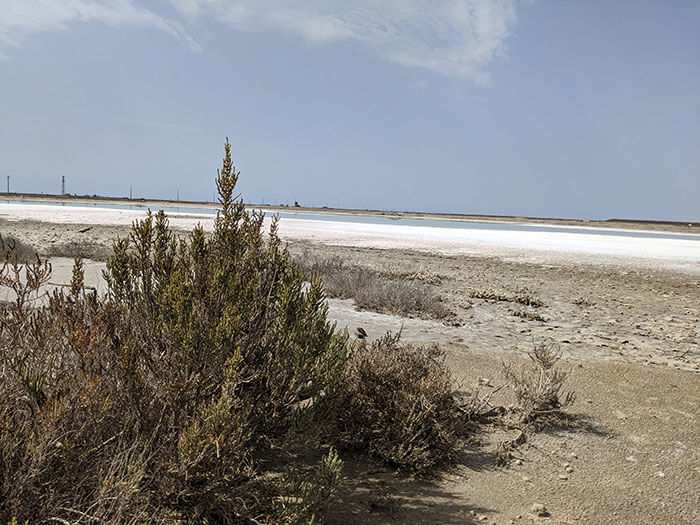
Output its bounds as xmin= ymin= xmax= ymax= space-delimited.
xmin=0 ymin=141 xmax=349 ymax=523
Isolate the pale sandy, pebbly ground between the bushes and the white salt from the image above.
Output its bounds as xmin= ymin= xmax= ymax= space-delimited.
xmin=0 ymin=214 xmax=700 ymax=525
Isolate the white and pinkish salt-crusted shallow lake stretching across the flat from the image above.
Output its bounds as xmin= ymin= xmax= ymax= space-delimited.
xmin=0 ymin=201 xmax=700 ymax=273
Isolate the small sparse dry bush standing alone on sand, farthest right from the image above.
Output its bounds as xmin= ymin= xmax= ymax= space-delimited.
xmin=502 ymin=343 xmax=575 ymax=423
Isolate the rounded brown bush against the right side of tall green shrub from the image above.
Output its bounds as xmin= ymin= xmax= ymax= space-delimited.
xmin=326 ymin=334 xmax=464 ymax=474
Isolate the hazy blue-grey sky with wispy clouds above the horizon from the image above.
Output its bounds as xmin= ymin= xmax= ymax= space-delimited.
xmin=0 ymin=0 xmax=700 ymax=221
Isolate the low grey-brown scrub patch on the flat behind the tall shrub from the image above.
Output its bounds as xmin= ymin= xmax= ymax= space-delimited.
xmin=296 ymin=253 xmax=454 ymax=320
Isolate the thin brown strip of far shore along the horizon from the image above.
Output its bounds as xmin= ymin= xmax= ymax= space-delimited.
xmin=0 ymin=192 xmax=700 ymax=234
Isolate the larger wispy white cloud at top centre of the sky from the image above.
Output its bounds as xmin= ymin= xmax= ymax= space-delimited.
xmin=170 ymin=0 xmax=516 ymax=84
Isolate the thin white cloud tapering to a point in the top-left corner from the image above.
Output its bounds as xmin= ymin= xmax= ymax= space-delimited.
xmin=0 ymin=0 xmax=200 ymax=57
